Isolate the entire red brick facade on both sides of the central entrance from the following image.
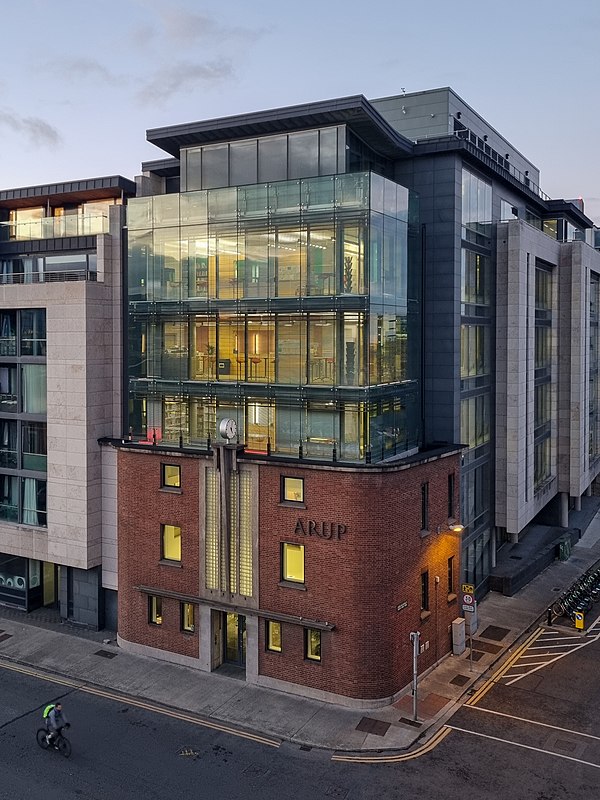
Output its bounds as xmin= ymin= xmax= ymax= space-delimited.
xmin=119 ymin=449 xmax=460 ymax=700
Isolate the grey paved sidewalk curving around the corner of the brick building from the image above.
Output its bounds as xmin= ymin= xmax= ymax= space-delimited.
xmin=0 ymin=512 xmax=600 ymax=751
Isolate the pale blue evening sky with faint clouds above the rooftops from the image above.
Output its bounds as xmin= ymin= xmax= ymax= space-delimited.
xmin=0 ymin=0 xmax=600 ymax=225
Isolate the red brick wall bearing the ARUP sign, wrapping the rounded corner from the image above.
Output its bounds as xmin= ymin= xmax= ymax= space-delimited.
xmin=259 ymin=457 xmax=459 ymax=698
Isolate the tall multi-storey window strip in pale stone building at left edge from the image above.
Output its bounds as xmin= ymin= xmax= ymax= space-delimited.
xmin=0 ymin=309 xmax=47 ymax=526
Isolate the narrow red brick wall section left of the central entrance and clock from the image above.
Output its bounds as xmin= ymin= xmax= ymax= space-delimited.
xmin=118 ymin=450 xmax=200 ymax=658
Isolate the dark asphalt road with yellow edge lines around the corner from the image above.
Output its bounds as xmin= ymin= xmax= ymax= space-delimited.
xmin=0 ymin=632 xmax=600 ymax=800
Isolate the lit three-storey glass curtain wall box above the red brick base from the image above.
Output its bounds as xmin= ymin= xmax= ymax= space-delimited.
xmin=128 ymin=175 xmax=421 ymax=462
